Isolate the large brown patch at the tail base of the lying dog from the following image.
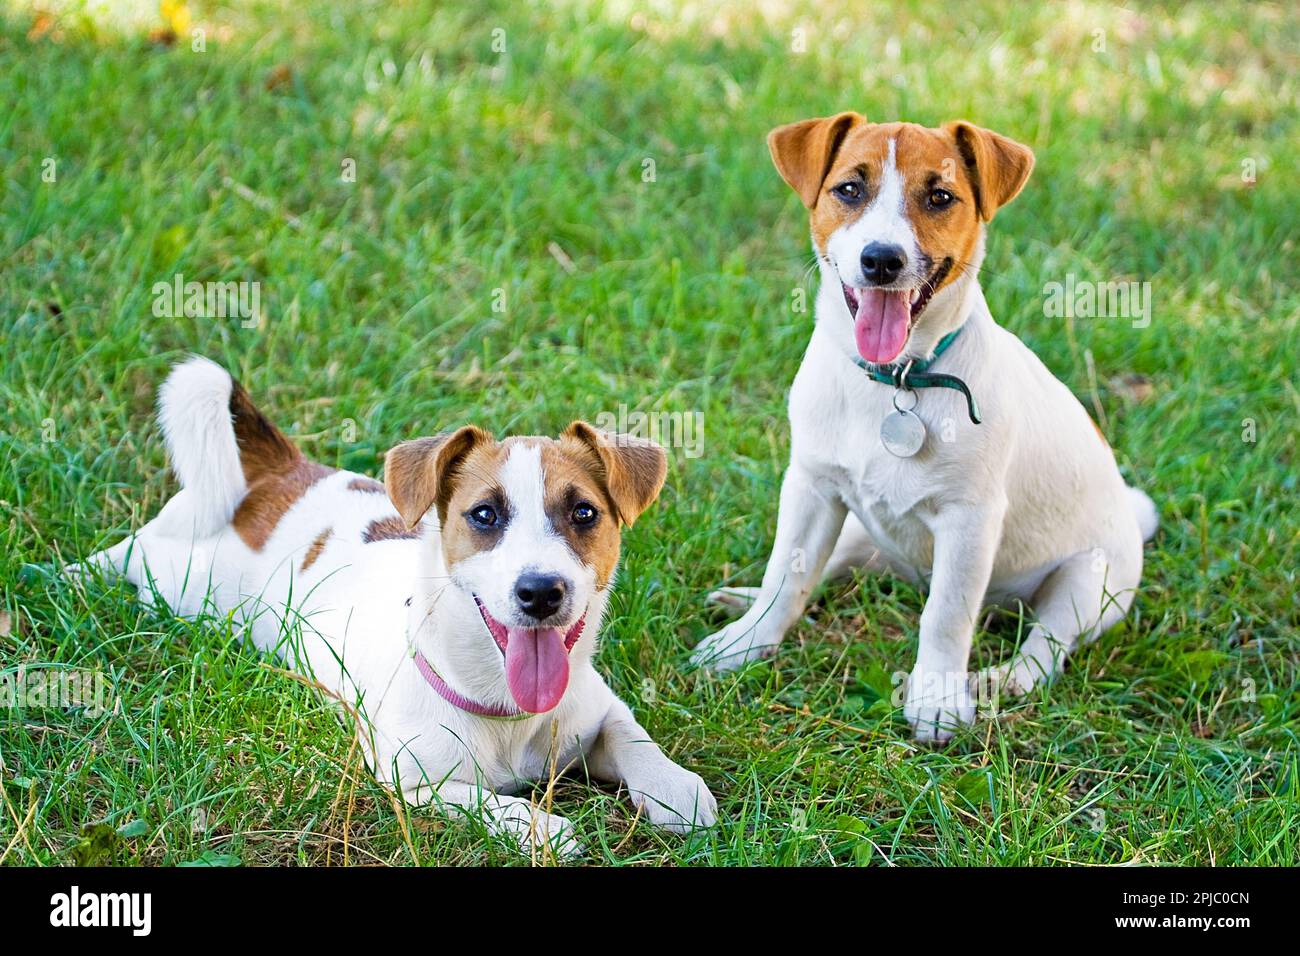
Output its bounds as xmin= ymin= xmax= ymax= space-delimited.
xmin=230 ymin=382 xmax=334 ymax=551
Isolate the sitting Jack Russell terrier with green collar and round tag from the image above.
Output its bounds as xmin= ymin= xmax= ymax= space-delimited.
xmin=694 ymin=112 xmax=1157 ymax=740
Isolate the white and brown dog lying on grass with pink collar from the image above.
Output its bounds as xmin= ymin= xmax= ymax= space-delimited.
xmin=78 ymin=358 xmax=716 ymax=853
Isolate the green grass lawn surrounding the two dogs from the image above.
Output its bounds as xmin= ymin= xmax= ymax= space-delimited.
xmin=0 ymin=0 xmax=1300 ymax=865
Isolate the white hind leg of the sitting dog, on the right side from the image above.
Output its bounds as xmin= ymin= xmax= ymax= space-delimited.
xmin=980 ymin=545 xmax=1141 ymax=695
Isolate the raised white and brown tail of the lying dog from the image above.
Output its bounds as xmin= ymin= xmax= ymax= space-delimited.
xmin=159 ymin=355 xmax=299 ymax=536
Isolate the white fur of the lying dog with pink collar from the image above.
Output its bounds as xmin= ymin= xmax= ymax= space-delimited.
xmin=86 ymin=358 xmax=716 ymax=853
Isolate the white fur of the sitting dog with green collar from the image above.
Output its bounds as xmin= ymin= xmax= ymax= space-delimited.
xmin=694 ymin=134 xmax=1157 ymax=740
